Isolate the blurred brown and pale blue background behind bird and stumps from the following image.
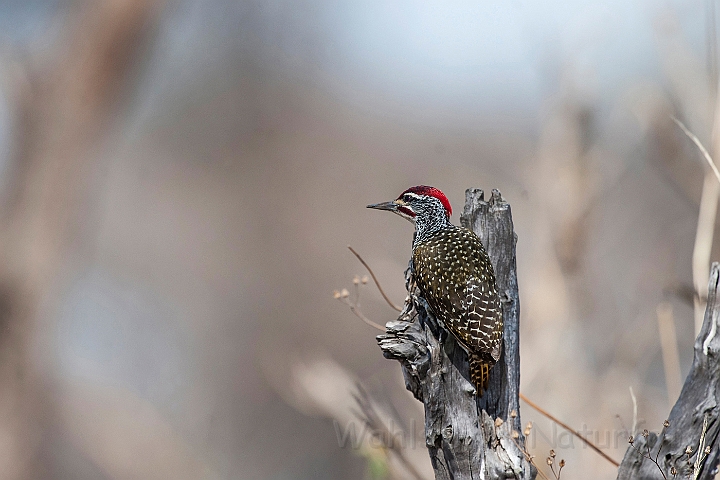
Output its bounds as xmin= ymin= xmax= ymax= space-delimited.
xmin=0 ymin=0 xmax=720 ymax=480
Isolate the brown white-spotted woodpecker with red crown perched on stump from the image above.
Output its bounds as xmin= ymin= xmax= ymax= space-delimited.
xmin=367 ymin=185 xmax=503 ymax=396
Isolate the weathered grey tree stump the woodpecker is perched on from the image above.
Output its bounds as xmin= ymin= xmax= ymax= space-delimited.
xmin=377 ymin=189 xmax=536 ymax=480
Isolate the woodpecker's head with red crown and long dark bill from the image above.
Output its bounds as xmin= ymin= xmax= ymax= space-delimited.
xmin=367 ymin=185 xmax=452 ymax=223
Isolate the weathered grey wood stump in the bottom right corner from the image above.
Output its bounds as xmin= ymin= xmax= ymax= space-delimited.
xmin=617 ymin=263 xmax=720 ymax=480
